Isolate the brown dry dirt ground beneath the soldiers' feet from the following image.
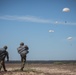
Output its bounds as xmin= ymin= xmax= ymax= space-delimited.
xmin=0 ymin=63 xmax=76 ymax=75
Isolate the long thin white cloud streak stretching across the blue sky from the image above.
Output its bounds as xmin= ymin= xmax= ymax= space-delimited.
xmin=0 ymin=15 xmax=76 ymax=25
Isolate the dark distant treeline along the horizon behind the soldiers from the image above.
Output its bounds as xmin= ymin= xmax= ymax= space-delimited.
xmin=6 ymin=60 xmax=76 ymax=64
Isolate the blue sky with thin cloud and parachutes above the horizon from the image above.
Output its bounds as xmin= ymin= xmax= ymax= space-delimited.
xmin=0 ymin=0 xmax=76 ymax=60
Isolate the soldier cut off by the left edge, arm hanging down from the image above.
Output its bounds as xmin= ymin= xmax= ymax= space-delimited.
xmin=0 ymin=46 xmax=9 ymax=71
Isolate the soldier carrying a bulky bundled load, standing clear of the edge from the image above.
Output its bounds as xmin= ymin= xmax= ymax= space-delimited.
xmin=17 ymin=42 xmax=29 ymax=71
